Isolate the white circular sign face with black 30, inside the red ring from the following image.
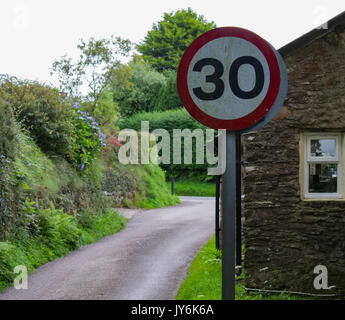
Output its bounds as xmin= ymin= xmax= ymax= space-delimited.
xmin=187 ymin=37 xmax=270 ymax=120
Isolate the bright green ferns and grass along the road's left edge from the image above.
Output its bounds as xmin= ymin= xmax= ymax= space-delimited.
xmin=0 ymin=209 xmax=126 ymax=291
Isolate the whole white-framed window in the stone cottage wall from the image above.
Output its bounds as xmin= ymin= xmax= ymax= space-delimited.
xmin=304 ymin=133 xmax=342 ymax=199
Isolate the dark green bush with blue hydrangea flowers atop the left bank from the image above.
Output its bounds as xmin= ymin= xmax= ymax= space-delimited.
xmin=0 ymin=79 xmax=105 ymax=170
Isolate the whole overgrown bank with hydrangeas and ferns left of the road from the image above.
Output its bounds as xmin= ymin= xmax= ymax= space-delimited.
xmin=0 ymin=78 xmax=178 ymax=290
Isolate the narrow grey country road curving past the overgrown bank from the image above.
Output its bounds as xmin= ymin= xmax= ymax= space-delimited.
xmin=0 ymin=197 xmax=214 ymax=300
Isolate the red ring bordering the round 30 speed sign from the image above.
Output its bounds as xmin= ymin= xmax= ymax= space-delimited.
xmin=177 ymin=27 xmax=280 ymax=131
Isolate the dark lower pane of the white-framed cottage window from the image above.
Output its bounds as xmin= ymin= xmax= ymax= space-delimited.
xmin=309 ymin=163 xmax=338 ymax=193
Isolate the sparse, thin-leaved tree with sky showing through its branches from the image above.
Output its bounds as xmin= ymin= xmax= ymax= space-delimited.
xmin=51 ymin=36 xmax=132 ymax=112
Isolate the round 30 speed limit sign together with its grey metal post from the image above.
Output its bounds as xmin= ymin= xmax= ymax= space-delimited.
xmin=177 ymin=27 xmax=287 ymax=300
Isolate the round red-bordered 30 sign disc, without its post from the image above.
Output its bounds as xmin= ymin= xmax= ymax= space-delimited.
xmin=177 ymin=27 xmax=287 ymax=131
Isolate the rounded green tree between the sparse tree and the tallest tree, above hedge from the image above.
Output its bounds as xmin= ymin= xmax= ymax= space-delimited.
xmin=112 ymin=59 xmax=166 ymax=116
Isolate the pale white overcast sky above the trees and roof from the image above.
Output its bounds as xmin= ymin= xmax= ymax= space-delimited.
xmin=0 ymin=0 xmax=345 ymax=87
